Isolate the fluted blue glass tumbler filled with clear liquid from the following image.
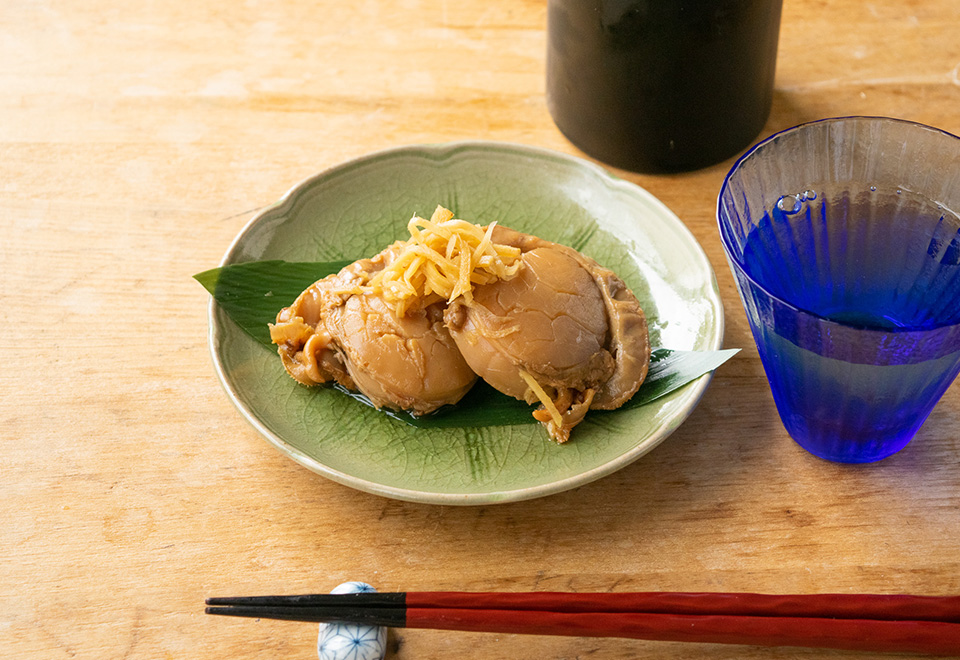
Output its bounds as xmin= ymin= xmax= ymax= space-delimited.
xmin=717 ymin=117 xmax=960 ymax=463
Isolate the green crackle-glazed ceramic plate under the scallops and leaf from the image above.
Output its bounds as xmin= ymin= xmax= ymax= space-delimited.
xmin=210 ymin=142 xmax=723 ymax=505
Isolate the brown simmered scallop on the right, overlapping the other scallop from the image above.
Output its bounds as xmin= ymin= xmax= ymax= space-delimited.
xmin=444 ymin=227 xmax=650 ymax=442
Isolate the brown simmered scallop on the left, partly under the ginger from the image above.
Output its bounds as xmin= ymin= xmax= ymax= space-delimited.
xmin=271 ymin=244 xmax=477 ymax=415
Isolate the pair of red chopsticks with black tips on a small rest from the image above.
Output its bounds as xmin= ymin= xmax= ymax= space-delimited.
xmin=207 ymin=592 xmax=960 ymax=655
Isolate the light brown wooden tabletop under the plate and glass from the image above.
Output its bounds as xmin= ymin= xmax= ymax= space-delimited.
xmin=0 ymin=0 xmax=960 ymax=660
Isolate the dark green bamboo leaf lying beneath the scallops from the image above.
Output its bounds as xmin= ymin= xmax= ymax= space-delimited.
xmin=194 ymin=260 xmax=739 ymax=428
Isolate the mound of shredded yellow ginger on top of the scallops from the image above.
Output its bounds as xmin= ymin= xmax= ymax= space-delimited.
xmin=343 ymin=206 xmax=522 ymax=317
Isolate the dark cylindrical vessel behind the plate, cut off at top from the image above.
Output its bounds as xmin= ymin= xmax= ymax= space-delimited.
xmin=547 ymin=0 xmax=781 ymax=172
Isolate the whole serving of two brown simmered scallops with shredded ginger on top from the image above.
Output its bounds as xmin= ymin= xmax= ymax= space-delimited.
xmin=270 ymin=206 xmax=650 ymax=442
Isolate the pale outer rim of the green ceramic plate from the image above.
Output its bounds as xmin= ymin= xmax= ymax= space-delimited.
xmin=207 ymin=140 xmax=725 ymax=506
